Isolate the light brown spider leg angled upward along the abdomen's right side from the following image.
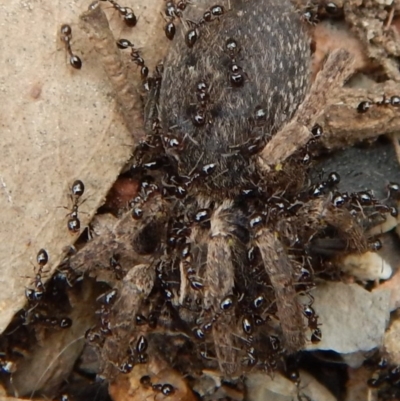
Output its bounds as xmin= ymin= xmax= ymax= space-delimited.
xmin=258 ymin=49 xmax=354 ymax=172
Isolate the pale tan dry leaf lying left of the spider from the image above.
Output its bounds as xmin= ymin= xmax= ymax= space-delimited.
xmin=0 ymin=0 xmax=167 ymax=331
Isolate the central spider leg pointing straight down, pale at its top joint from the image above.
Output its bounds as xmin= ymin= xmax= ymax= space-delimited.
xmin=200 ymin=201 xmax=253 ymax=375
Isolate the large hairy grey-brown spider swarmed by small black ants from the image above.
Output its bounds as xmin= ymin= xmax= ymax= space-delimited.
xmin=61 ymin=0 xmax=396 ymax=379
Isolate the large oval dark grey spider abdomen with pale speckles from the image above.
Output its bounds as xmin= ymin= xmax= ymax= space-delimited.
xmin=159 ymin=0 xmax=310 ymax=196
